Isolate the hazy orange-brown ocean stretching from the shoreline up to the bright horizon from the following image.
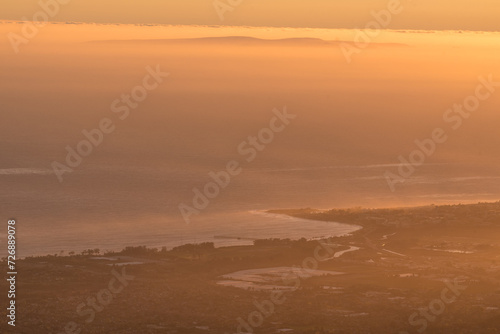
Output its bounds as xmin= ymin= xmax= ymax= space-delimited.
xmin=0 ymin=26 xmax=500 ymax=256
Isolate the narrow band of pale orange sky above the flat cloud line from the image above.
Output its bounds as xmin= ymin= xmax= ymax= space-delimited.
xmin=0 ymin=0 xmax=500 ymax=31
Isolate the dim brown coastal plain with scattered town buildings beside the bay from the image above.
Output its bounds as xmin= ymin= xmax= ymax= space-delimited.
xmin=0 ymin=202 xmax=500 ymax=334
